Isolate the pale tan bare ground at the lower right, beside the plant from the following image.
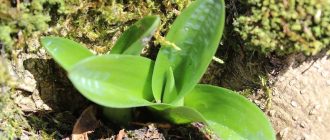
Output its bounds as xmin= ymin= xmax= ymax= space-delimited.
xmin=268 ymin=56 xmax=330 ymax=140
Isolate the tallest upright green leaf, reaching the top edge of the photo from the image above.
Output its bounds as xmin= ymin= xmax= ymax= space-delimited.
xmin=152 ymin=0 xmax=225 ymax=100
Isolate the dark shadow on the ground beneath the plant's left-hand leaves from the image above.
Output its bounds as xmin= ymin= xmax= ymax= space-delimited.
xmin=24 ymin=58 xmax=90 ymax=137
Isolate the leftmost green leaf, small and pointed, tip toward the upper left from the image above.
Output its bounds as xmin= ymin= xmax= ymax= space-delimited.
xmin=41 ymin=37 xmax=93 ymax=71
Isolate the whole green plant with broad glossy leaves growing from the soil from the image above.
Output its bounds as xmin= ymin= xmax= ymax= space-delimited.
xmin=41 ymin=0 xmax=275 ymax=140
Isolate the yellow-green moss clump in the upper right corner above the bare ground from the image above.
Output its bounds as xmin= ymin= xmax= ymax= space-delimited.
xmin=234 ymin=0 xmax=330 ymax=55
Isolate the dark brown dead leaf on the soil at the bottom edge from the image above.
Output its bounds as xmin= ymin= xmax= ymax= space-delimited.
xmin=72 ymin=105 xmax=100 ymax=140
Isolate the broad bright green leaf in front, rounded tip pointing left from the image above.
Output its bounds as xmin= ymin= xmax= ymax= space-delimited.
xmin=69 ymin=54 xmax=154 ymax=108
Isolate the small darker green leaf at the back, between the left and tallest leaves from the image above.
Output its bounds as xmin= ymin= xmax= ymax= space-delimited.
xmin=110 ymin=16 xmax=160 ymax=55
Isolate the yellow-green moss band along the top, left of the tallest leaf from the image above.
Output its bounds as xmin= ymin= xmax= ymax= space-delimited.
xmin=0 ymin=0 xmax=191 ymax=53
